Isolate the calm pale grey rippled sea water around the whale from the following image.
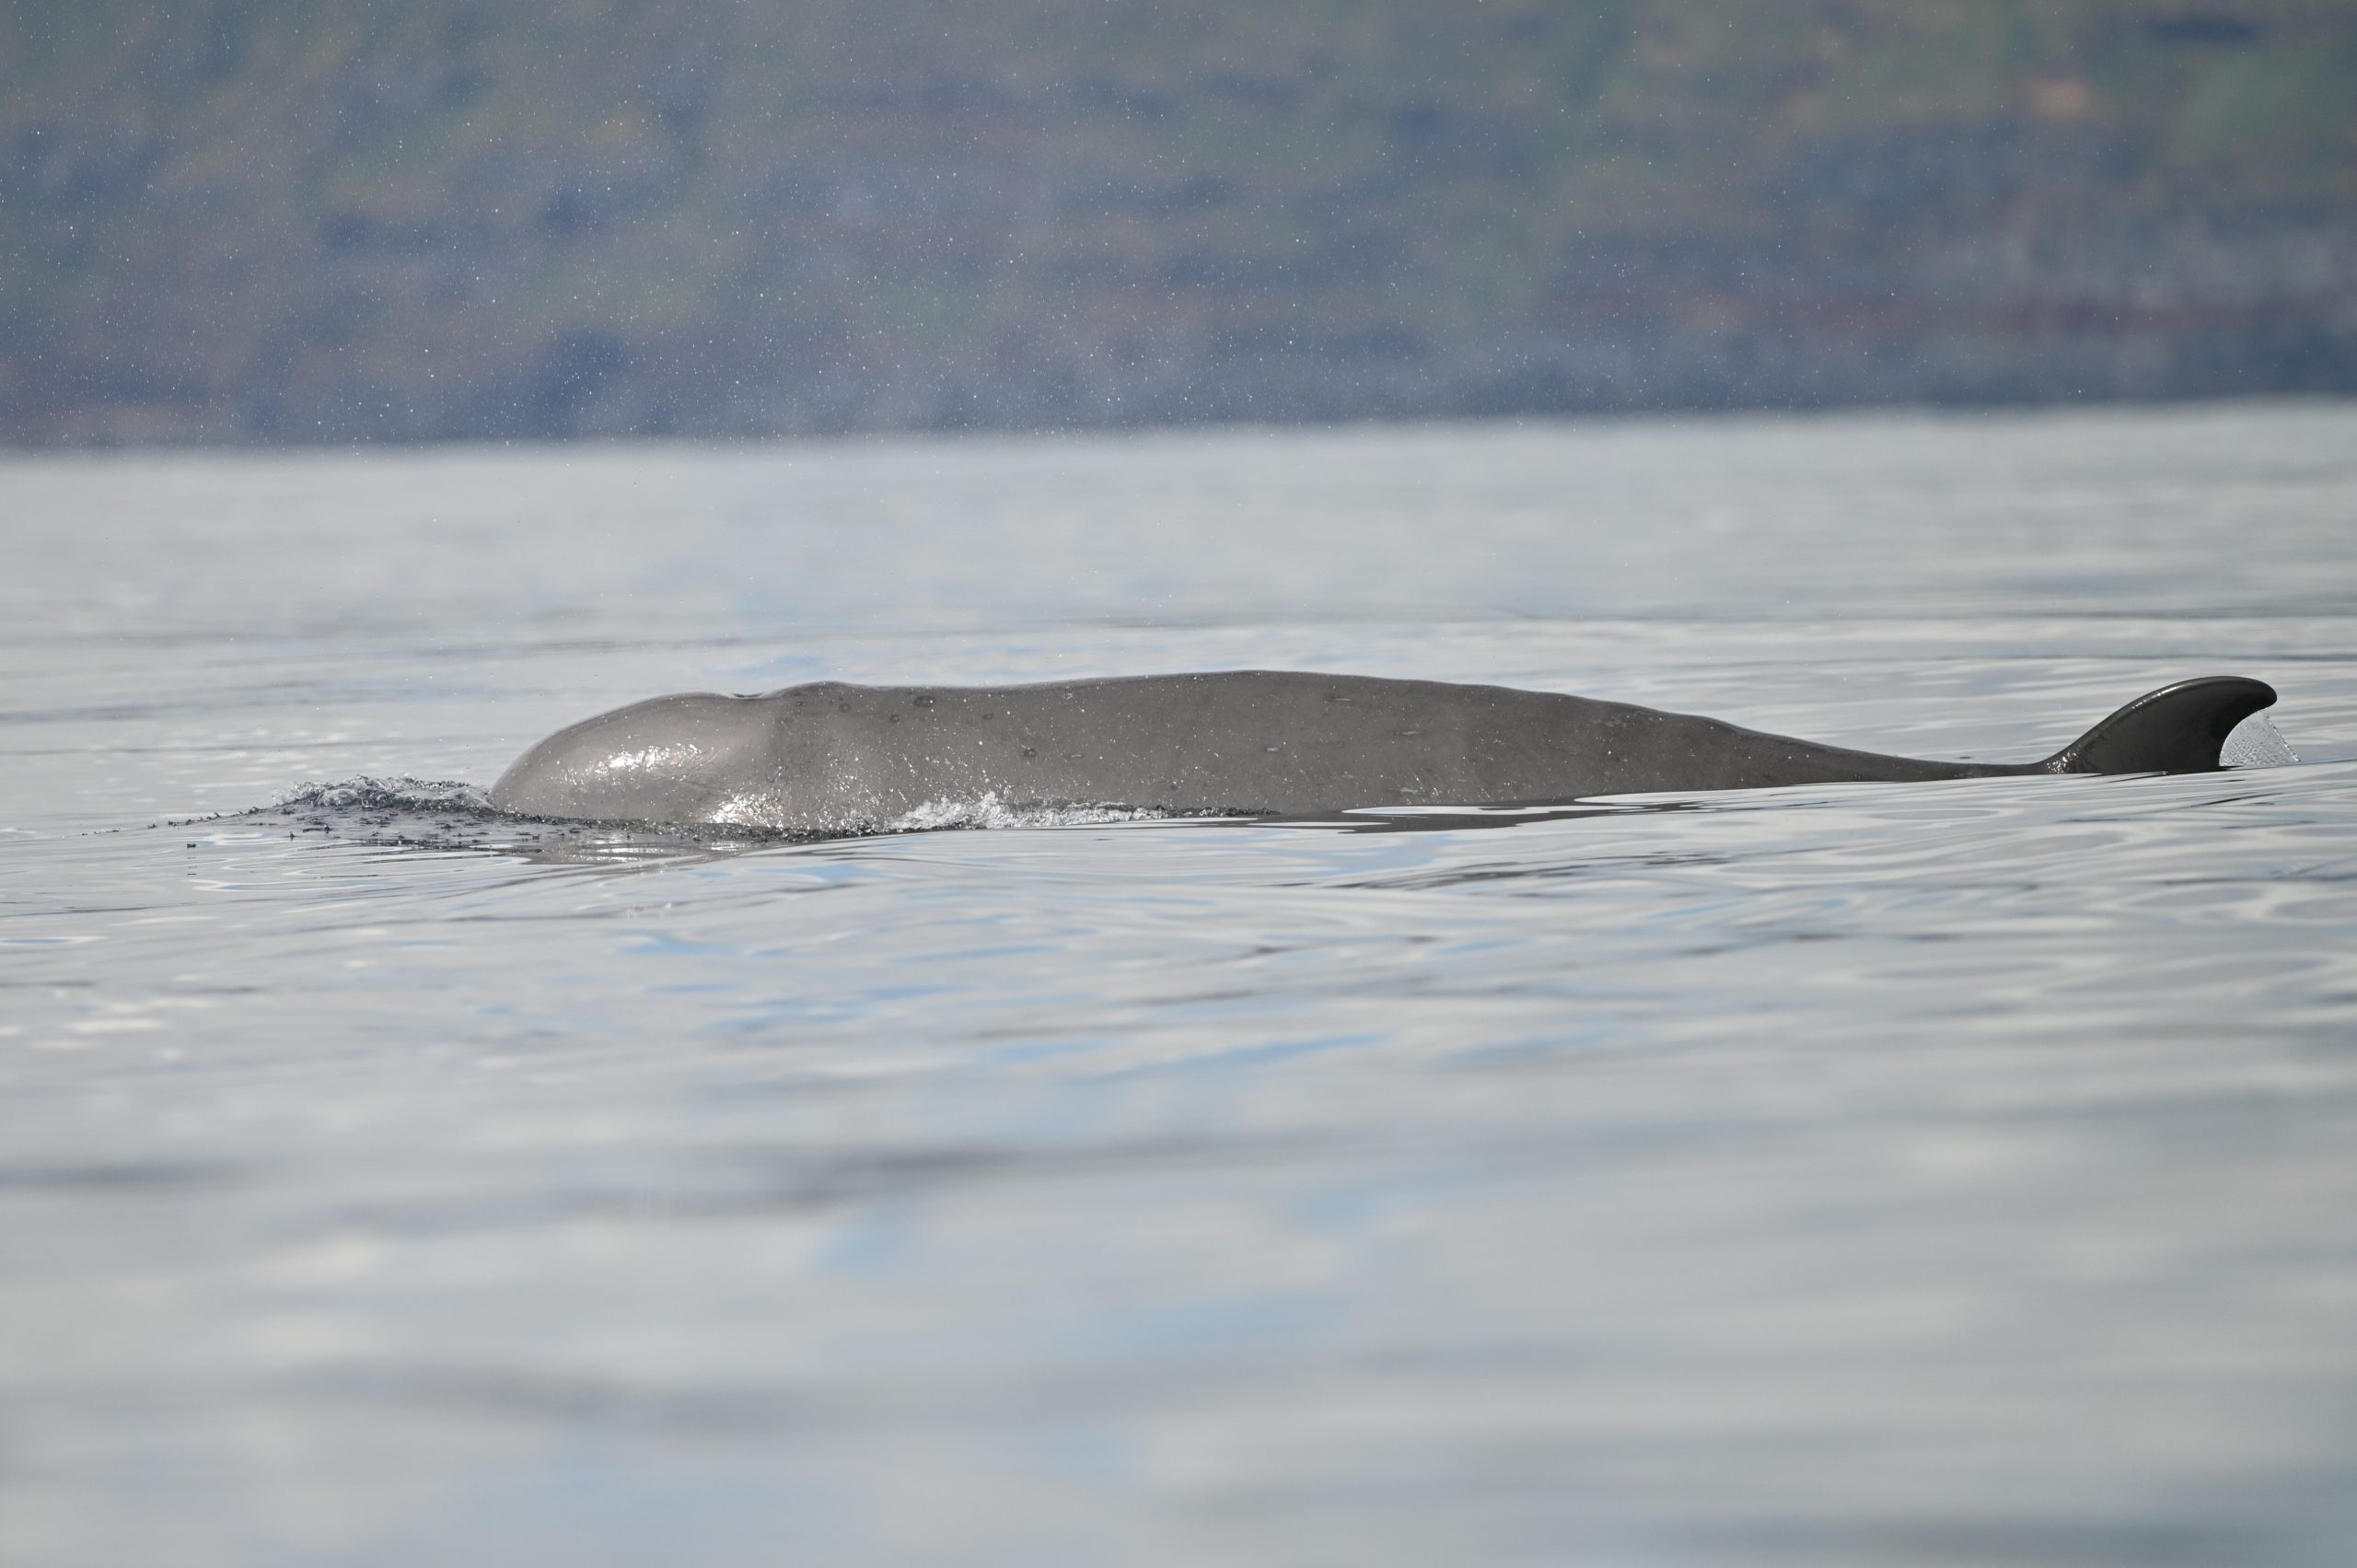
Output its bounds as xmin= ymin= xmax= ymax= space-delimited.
xmin=0 ymin=403 xmax=2357 ymax=1568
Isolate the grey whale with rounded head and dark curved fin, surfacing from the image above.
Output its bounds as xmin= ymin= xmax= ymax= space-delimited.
xmin=490 ymin=669 xmax=2274 ymax=832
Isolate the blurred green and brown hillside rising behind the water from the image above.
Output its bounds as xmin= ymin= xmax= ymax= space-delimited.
xmin=0 ymin=0 xmax=2357 ymax=443
